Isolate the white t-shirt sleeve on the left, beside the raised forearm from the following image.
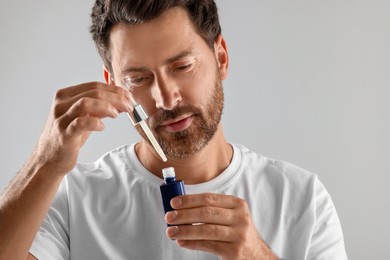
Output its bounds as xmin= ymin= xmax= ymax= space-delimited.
xmin=30 ymin=177 xmax=70 ymax=260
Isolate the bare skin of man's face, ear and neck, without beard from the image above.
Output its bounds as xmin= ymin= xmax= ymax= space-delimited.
xmin=106 ymin=10 xmax=232 ymax=184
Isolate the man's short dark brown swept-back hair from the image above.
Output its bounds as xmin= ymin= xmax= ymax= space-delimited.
xmin=90 ymin=0 xmax=221 ymax=71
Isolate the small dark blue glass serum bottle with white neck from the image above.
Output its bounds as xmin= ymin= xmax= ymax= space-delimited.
xmin=160 ymin=167 xmax=185 ymax=216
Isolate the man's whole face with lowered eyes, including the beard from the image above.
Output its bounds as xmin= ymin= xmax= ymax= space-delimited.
xmin=110 ymin=8 xmax=227 ymax=158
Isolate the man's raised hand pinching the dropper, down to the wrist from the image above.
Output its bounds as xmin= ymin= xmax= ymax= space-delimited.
xmin=36 ymin=82 xmax=132 ymax=177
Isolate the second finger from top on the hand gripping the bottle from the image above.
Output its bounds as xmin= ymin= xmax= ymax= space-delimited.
xmin=165 ymin=206 xmax=235 ymax=225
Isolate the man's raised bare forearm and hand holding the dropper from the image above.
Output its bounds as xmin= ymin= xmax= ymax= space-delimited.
xmin=0 ymin=82 xmax=132 ymax=259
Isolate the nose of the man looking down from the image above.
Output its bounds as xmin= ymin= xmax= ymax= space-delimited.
xmin=152 ymin=72 xmax=182 ymax=110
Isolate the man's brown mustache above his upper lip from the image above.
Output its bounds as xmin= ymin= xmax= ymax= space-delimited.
xmin=149 ymin=106 xmax=202 ymax=129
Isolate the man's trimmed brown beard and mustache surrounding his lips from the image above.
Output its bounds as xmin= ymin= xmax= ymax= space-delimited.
xmin=137 ymin=72 xmax=224 ymax=158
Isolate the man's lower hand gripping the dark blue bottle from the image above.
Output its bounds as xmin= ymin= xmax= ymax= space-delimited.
xmin=165 ymin=193 xmax=277 ymax=260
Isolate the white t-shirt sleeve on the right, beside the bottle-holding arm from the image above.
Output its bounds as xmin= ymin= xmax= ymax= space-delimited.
xmin=307 ymin=179 xmax=348 ymax=260
